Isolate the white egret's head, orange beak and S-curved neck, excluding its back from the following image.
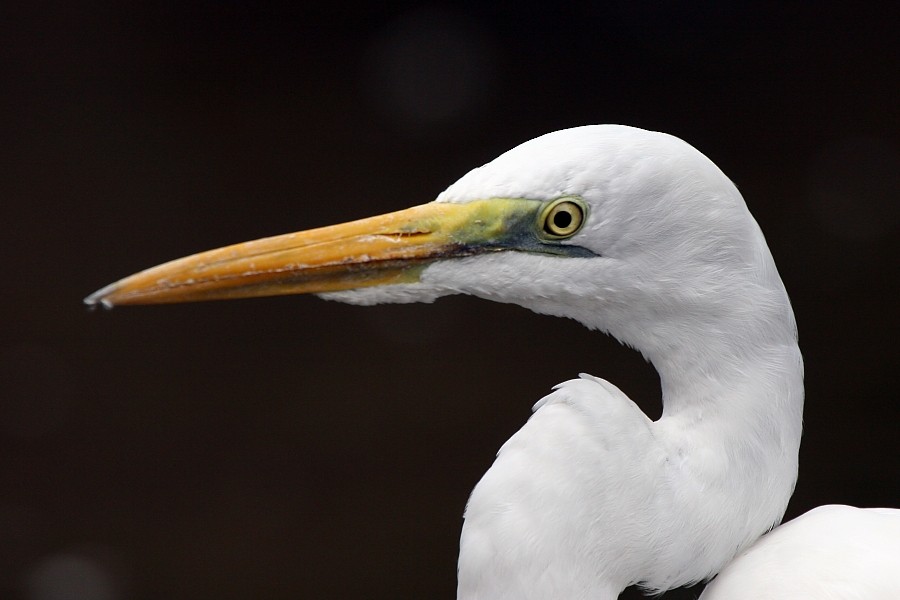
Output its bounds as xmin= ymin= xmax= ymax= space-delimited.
xmin=86 ymin=125 xmax=892 ymax=600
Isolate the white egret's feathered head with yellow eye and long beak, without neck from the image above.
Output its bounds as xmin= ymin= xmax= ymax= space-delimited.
xmin=85 ymin=125 xmax=783 ymax=354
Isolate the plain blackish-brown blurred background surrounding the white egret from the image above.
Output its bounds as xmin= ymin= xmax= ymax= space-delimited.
xmin=0 ymin=2 xmax=900 ymax=600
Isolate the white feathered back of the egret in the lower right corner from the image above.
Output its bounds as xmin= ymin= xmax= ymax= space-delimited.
xmin=700 ymin=505 xmax=900 ymax=600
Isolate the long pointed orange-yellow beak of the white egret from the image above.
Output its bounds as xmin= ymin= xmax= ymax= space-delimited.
xmin=84 ymin=198 xmax=541 ymax=307
